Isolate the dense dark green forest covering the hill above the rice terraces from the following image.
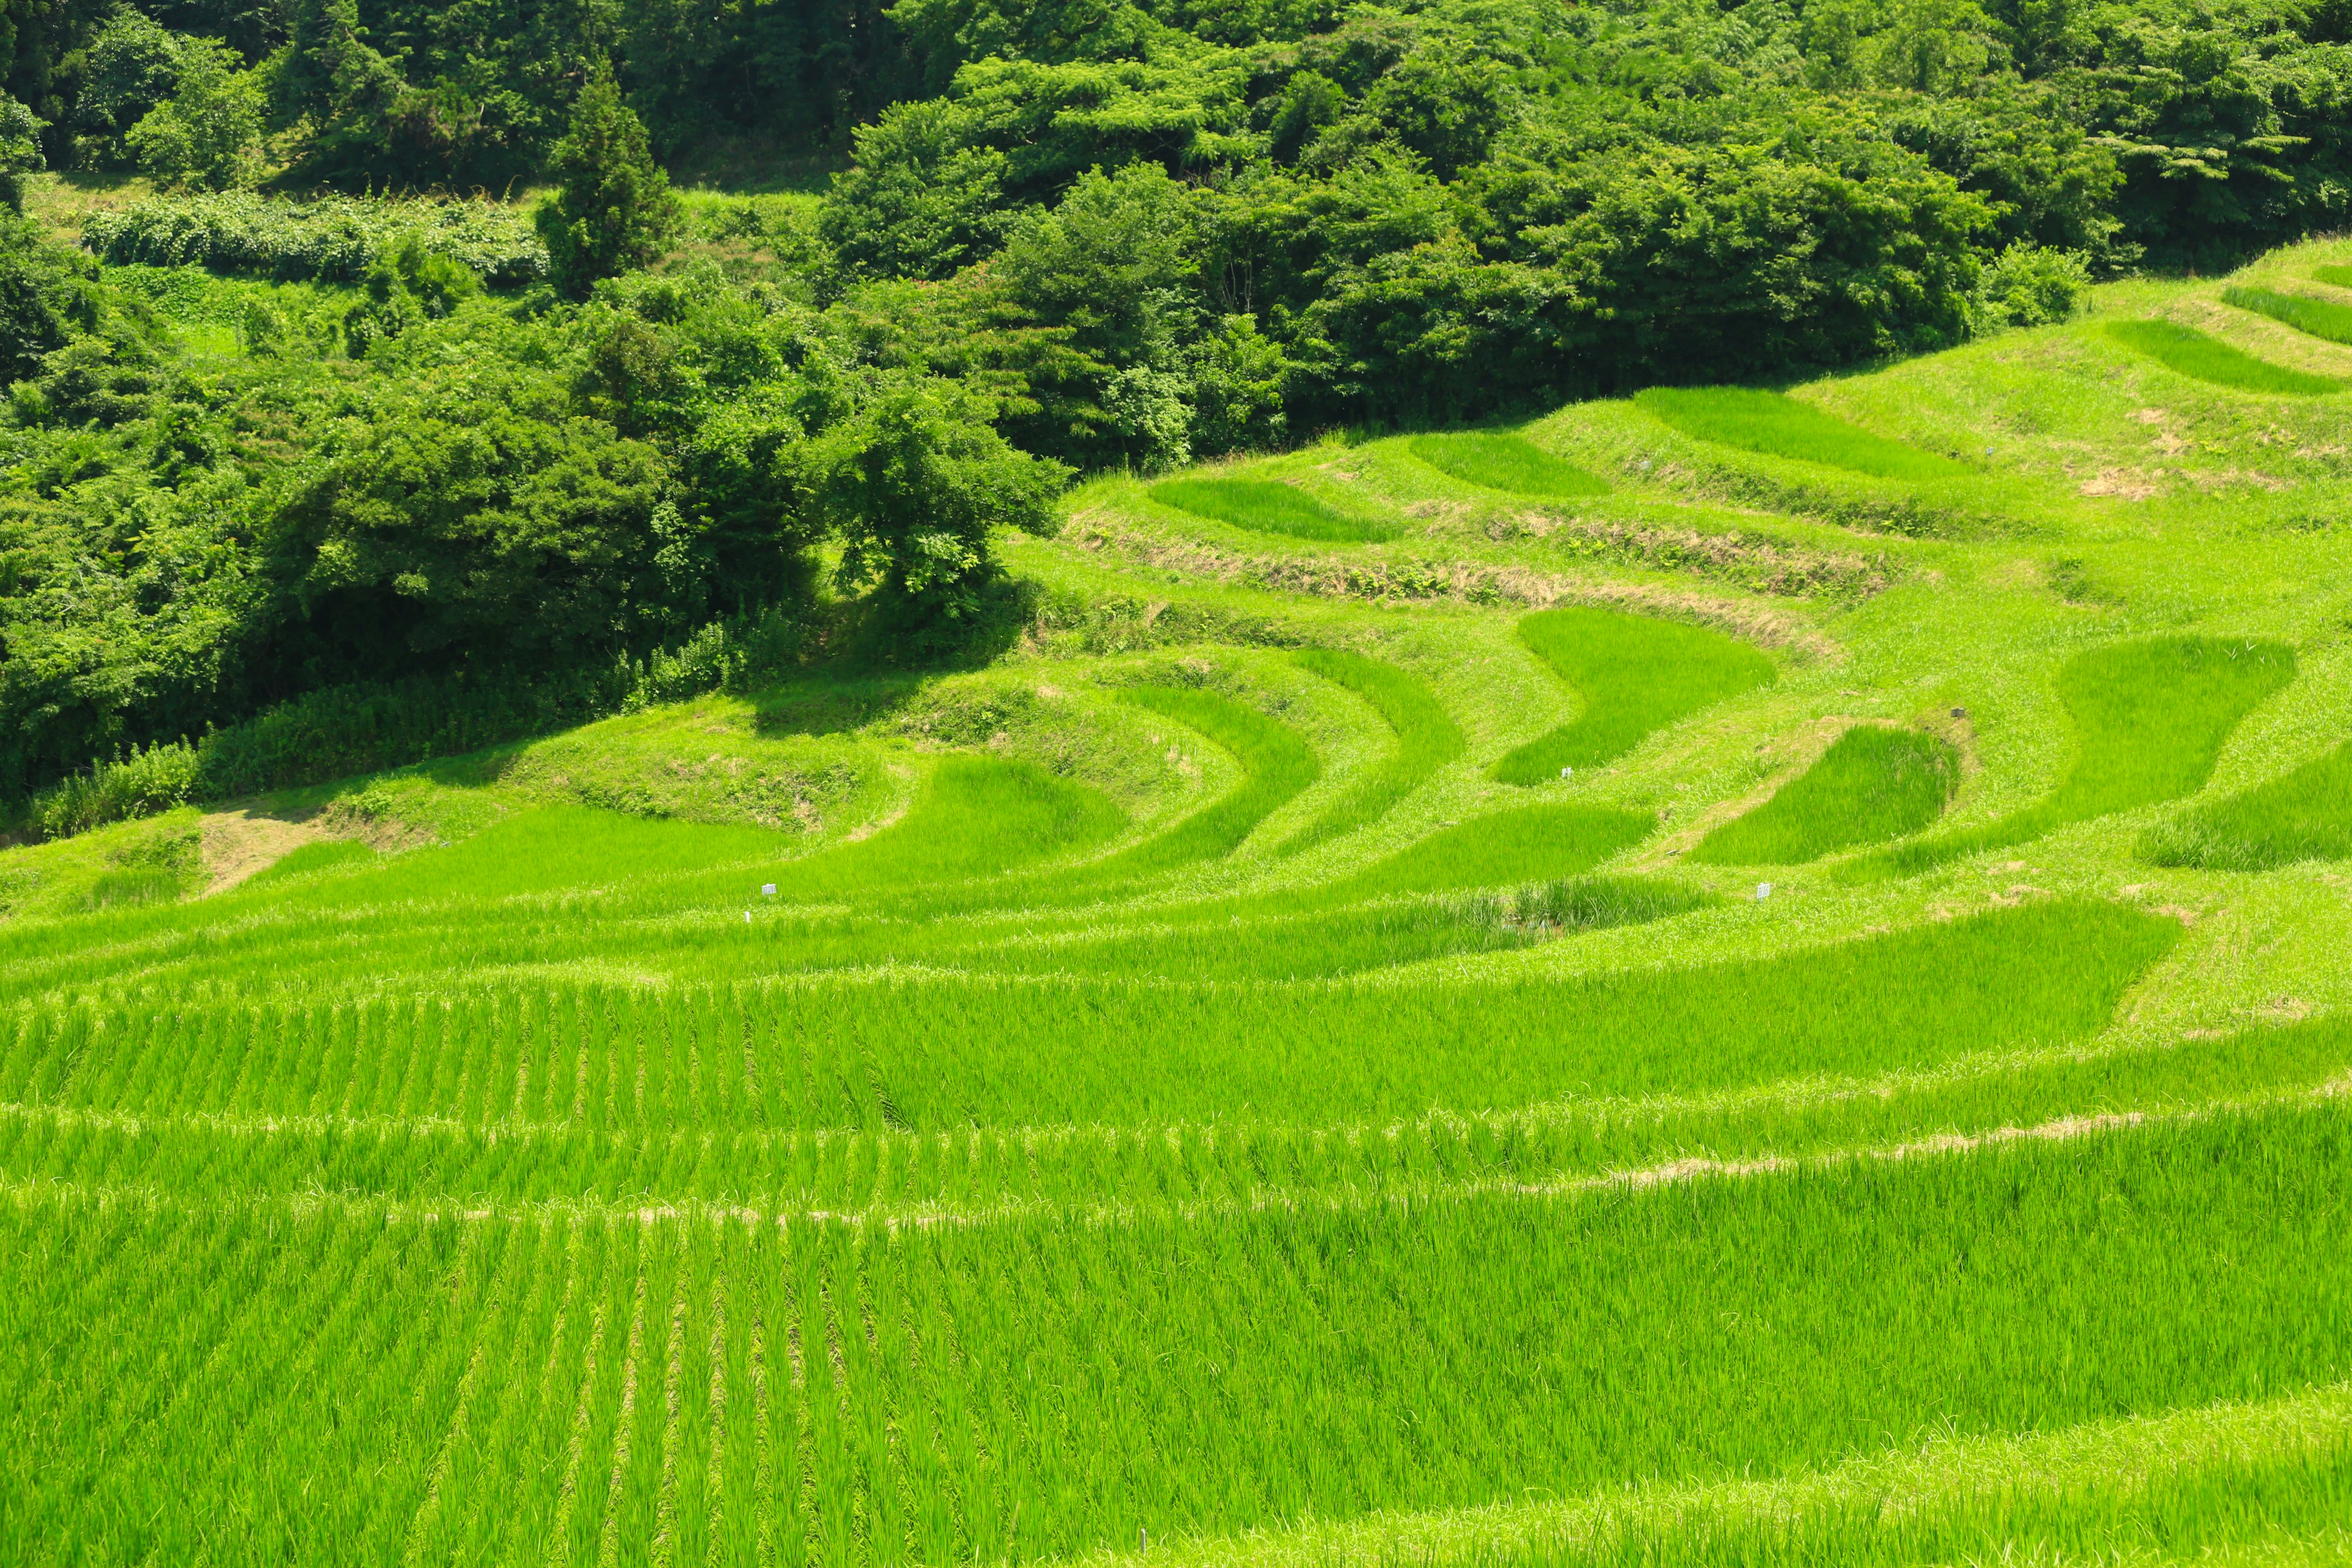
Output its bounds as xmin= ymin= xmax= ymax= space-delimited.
xmin=0 ymin=0 xmax=2352 ymax=827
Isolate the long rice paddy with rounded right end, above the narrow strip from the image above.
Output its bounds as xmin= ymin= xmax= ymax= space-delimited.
xmin=0 ymin=903 xmax=2180 ymax=1128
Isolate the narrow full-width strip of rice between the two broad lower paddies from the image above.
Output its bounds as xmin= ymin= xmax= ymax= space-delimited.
xmin=0 ymin=1018 xmax=2352 ymax=1225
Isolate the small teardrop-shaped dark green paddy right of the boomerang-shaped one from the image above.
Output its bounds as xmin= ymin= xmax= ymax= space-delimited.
xmin=1691 ymin=724 xmax=1959 ymax=865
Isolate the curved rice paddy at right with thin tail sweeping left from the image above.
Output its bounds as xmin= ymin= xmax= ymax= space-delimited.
xmin=1849 ymin=637 xmax=2296 ymax=877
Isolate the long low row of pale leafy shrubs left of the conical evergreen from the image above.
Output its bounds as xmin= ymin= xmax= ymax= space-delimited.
xmin=82 ymin=190 xmax=548 ymax=287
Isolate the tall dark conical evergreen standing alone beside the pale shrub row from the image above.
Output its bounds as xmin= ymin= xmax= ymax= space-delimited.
xmin=538 ymin=75 xmax=684 ymax=298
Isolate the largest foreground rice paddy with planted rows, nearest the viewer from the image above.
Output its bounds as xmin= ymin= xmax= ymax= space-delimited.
xmin=0 ymin=1102 xmax=2352 ymax=1563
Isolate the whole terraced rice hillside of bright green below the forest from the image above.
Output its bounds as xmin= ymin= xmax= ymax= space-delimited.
xmin=13 ymin=247 xmax=2352 ymax=1568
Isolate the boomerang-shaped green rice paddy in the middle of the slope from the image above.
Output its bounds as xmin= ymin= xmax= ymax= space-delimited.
xmin=1493 ymin=606 xmax=1778 ymax=785
